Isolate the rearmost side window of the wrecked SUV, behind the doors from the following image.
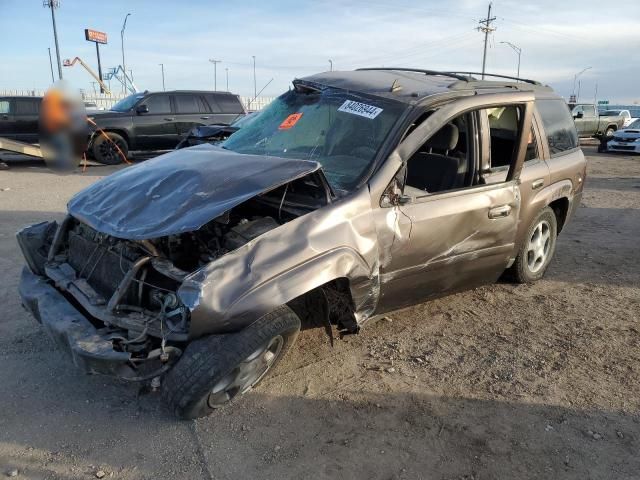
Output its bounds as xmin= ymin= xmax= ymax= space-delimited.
xmin=536 ymin=100 xmax=578 ymax=157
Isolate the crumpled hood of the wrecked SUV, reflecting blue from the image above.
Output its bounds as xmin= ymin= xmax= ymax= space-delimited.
xmin=67 ymin=144 xmax=320 ymax=240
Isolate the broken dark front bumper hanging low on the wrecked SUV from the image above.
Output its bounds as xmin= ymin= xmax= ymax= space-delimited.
xmin=19 ymin=268 xmax=138 ymax=380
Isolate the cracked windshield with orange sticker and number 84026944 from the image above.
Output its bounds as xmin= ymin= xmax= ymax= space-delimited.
xmin=222 ymin=85 xmax=403 ymax=191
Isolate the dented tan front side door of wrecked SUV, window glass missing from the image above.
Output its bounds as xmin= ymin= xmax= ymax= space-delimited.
xmin=375 ymin=93 xmax=533 ymax=313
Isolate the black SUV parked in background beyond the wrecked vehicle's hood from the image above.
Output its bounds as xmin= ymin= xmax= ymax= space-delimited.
xmin=89 ymin=90 xmax=246 ymax=164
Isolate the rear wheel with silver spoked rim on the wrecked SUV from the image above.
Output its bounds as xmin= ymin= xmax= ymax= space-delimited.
xmin=508 ymin=207 xmax=558 ymax=283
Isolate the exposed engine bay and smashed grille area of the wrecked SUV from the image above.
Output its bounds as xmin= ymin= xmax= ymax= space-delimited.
xmin=24 ymin=172 xmax=329 ymax=379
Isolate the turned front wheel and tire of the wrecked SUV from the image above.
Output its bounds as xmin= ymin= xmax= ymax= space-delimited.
xmin=162 ymin=305 xmax=300 ymax=419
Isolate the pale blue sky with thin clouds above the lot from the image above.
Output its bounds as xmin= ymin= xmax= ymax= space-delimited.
xmin=0 ymin=0 xmax=640 ymax=103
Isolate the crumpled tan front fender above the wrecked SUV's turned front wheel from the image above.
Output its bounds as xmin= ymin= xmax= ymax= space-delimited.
xmin=178 ymin=188 xmax=379 ymax=337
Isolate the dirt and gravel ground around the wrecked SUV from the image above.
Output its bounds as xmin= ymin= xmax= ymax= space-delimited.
xmin=0 ymin=147 xmax=640 ymax=480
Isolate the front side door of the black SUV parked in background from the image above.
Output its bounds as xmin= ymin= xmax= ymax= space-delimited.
xmin=132 ymin=93 xmax=179 ymax=150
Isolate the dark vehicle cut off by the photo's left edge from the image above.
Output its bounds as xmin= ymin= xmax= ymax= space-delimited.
xmin=0 ymin=97 xmax=42 ymax=143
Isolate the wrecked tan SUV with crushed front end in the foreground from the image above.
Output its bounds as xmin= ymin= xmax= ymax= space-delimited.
xmin=17 ymin=68 xmax=586 ymax=418
